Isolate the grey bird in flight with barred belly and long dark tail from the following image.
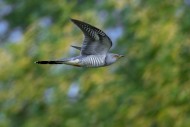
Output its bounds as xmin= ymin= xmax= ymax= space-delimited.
xmin=35 ymin=18 xmax=124 ymax=68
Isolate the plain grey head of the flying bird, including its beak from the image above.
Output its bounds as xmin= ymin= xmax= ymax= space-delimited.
xmin=106 ymin=53 xmax=124 ymax=65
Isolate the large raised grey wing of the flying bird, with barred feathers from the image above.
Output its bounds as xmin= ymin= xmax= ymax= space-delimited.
xmin=71 ymin=19 xmax=112 ymax=55
